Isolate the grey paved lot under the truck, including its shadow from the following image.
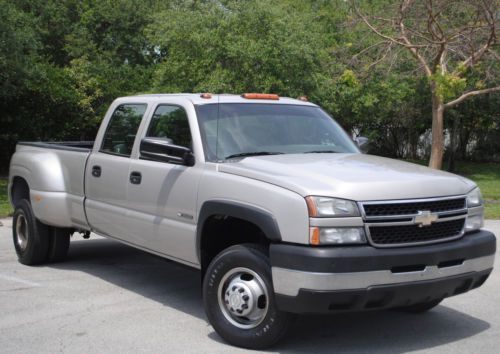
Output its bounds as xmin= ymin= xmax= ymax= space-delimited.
xmin=0 ymin=219 xmax=500 ymax=353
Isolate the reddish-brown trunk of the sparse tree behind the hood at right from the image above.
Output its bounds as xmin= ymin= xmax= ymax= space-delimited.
xmin=429 ymin=92 xmax=444 ymax=170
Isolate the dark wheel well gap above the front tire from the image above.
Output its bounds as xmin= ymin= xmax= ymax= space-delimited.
xmin=200 ymin=215 xmax=270 ymax=276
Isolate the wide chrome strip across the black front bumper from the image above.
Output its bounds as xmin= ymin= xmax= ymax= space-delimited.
xmin=272 ymin=255 xmax=495 ymax=296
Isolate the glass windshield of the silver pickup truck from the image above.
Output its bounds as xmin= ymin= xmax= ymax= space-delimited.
xmin=196 ymin=103 xmax=359 ymax=162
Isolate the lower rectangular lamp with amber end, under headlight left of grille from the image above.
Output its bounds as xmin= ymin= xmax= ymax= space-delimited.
xmin=310 ymin=227 xmax=366 ymax=246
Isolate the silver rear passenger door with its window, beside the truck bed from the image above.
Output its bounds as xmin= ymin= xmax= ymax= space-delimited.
xmin=85 ymin=103 xmax=147 ymax=241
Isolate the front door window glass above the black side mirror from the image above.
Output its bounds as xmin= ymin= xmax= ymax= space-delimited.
xmin=146 ymin=105 xmax=191 ymax=148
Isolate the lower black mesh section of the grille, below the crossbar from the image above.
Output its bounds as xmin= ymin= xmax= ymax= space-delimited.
xmin=369 ymin=219 xmax=465 ymax=245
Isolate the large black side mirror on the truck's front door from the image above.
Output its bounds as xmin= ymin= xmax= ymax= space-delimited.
xmin=139 ymin=138 xmax=194 ymax=166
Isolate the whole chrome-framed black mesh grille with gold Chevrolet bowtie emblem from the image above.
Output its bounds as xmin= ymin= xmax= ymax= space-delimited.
xmin=359 ymin=196 xmax=467 ymax=247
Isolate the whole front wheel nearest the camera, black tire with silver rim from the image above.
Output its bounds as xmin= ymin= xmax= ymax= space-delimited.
xmin=203 ymin=244 xmax=294 ymax=349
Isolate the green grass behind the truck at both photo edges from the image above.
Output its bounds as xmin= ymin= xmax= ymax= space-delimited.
xmin=0 ymin=161 xmax=500 ymax=219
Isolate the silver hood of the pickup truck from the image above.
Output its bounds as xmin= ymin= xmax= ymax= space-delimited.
xmin=218 ymin=154 xmax=475 ymax=201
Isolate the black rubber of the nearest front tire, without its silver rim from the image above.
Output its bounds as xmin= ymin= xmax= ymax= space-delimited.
xmin=203 ymin=246 xmax=288 ymax=349
